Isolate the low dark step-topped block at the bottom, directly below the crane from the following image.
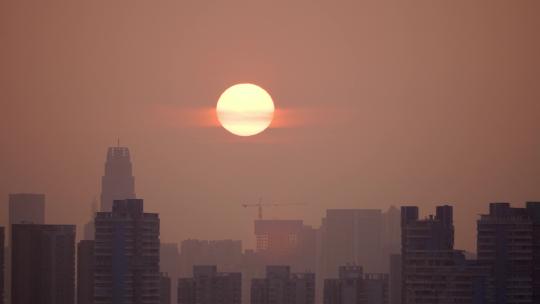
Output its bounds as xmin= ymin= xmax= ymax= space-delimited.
xmin=251 ymin=266 xmax=315 ymax=304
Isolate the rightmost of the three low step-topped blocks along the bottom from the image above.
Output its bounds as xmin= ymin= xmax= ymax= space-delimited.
xmin=324 ymin=265 xmax=388 ymax=304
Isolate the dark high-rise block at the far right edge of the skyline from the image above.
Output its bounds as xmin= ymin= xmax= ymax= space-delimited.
xmin=477 ymin=202 xmax=540 ymax=304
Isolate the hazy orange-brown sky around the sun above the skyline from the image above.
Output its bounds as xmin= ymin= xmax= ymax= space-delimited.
xmin=0 ymin=0 xmax=540 ymax=250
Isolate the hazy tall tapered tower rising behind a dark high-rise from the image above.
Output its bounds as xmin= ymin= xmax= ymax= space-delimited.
xmin=101 ymin=147 xmax=135 ymax=212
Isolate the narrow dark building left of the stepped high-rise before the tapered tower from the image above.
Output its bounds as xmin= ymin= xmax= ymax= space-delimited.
xmin=77 ymin=240 xmax=95 ymax=304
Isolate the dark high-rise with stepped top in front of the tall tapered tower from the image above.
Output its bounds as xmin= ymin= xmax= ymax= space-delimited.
xmin=94 ymin=199 xmax=160 ymax=304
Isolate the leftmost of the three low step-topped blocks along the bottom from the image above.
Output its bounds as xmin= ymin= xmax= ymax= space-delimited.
xmin=177 ymin=266 xmax=242 ymax=304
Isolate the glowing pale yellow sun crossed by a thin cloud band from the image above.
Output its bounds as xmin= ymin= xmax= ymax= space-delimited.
xmin=216 ymin=83 xmax=275 ymax=136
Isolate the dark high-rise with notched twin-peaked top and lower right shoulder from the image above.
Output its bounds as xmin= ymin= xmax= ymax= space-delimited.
xmin=401 ymin=205 xmax=487 ymax=304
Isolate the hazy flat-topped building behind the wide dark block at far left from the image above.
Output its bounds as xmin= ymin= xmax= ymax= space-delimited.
xmin=5 ymin=193 xmax=45 ymax=303
